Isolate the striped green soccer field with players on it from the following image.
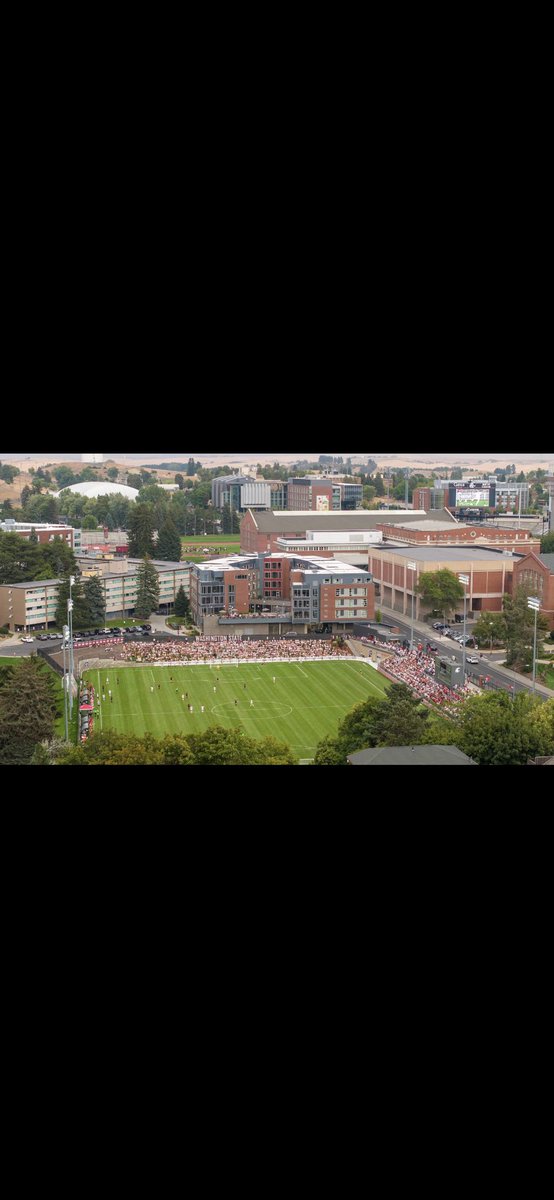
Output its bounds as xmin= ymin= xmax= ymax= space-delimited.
xmin=85 ymin=659 xmax=387 ymax=758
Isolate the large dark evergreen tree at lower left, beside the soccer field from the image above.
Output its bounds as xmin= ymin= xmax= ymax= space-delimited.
xmin=0 ymin=654 xmax=59 ymax=763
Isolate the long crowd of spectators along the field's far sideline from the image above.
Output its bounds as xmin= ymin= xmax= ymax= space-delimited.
xmin=121 ymin=636 xmax=350 ymax=662
